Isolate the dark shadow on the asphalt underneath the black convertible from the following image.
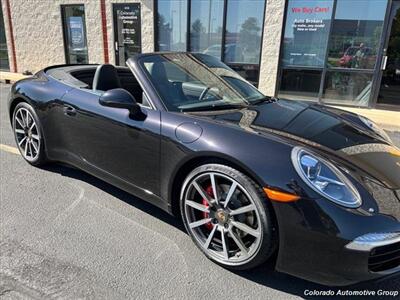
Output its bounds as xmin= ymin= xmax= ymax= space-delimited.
xmin=42 ymin=164 xmax=400 ymax=299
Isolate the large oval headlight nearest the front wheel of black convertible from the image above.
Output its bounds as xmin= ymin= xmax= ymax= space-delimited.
xmin=292 ymin=147 xmax=361 ymax=208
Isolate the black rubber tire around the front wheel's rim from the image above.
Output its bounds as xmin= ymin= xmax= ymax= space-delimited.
xmin=180 ymin=164 xmax=278 ymax=270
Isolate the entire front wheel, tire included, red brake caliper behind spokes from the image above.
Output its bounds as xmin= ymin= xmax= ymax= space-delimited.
xmin=181 ymin=164 xmax=276 ymax=270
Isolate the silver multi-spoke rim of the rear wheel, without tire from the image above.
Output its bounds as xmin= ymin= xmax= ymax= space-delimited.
xmin=14 ymin=107 xmax=40 ymax=161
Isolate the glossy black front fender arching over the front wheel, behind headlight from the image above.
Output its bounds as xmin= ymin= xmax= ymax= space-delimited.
xmin=160 ymin=112 xmax=297 ymax=211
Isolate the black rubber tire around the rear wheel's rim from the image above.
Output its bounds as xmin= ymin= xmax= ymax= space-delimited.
xmin=12 ymin=102 xmax=48 ymax=167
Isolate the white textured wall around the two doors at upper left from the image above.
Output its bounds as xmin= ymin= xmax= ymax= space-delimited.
xmin=2 ymin=0 xmax=154 ymax=72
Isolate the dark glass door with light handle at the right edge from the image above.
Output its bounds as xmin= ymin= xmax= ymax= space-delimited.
xmin=378 ymin=1 xmax=400 ymax=108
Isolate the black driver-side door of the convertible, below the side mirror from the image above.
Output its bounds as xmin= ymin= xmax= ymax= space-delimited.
xmin=59 ymin=89 xmax=160 ymax=195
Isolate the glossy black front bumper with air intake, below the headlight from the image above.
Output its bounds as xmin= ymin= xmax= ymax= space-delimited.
xmin=273 ymin=199 xmax=400 ymax=286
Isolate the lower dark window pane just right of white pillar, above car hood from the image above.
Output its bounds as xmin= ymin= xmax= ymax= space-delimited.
xmin=279 ymin=69 xmax=322 ymax=100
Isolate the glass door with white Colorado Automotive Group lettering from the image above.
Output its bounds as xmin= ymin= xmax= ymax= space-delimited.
xmin=113 ymin=3 xmax=142 ymax=66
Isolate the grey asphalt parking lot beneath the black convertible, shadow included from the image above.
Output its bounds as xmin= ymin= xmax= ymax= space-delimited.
xmin=0 ymin=84 xmax=400 ymax=299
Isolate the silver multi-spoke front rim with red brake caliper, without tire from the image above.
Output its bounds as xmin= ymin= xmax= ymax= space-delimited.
xmin=184 ymin=172 xmax=263 ymax=266
